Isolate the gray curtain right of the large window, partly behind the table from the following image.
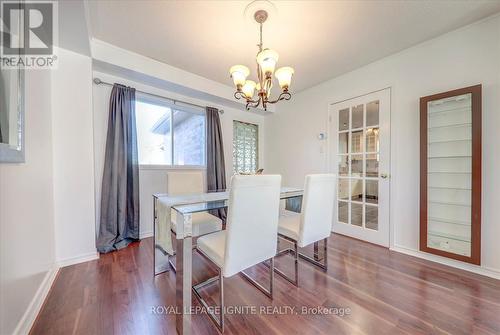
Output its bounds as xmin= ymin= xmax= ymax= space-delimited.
xmin=207 ymin=107 xmax=226 ymax=220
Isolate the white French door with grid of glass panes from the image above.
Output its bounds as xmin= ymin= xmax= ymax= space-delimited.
xmin=329 ymin=88 xmax=390 ymax=247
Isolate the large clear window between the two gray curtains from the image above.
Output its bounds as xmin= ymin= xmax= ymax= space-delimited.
xmin=135 ymin=98 xmax=206 ymax=166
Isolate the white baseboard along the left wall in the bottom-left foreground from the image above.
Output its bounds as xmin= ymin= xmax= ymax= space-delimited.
xmin=13 ymin=267 xmax=59 ymax=335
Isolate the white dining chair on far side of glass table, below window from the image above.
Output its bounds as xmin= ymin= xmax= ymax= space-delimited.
xmin=167 ymin=171 xmax=222 ymax=271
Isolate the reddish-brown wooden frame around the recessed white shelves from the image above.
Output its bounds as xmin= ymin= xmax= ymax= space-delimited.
xmin=420 ymin=85 xmax=482 ymax=265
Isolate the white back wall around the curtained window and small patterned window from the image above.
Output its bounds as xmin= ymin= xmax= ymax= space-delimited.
xmin=93 ymin=71 xmax=265 ymax=237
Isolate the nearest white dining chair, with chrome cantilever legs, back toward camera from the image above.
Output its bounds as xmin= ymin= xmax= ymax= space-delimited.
xmin=193 ymin=175 xmax=281 ymax=332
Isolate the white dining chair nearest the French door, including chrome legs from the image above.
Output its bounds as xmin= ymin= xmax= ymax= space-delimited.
xmin=275 ymin=174 xmax=335 ymax=286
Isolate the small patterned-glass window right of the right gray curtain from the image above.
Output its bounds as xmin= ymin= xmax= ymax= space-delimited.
xmin=233 ymin=121 xmax=259 ymax=173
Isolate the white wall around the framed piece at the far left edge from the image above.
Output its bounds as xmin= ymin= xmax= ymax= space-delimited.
xmin=0 ymin=70 xmax=55 ymax=334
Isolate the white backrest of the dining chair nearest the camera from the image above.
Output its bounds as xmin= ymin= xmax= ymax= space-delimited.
xmin=223 ymin=175 xmax=281 ymax=277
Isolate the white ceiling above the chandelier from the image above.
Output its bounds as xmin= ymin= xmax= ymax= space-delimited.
xmin=89 ymin=0 xmax=500 ymax=91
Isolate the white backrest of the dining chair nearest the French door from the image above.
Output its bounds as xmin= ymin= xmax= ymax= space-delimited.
xmin=298 ymin=174 xmax=336 ymax=247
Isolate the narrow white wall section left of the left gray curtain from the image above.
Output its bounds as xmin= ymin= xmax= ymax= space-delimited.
xmin=52 ymin=49 xmax=97 ymax=265
